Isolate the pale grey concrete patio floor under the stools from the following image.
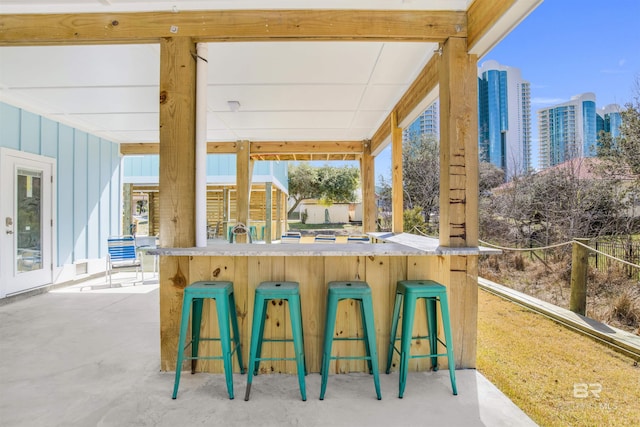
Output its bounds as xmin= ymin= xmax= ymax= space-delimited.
xmin=0 ymin=273 xmax=536 ymax=427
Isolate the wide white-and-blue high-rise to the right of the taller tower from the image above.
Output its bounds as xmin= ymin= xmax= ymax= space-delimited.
xmin=538 ymin=92 xmax=598 ymax=168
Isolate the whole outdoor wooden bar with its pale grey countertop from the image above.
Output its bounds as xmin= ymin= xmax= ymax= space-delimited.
xmin=149 ymin=233 xmax=498 ymax=373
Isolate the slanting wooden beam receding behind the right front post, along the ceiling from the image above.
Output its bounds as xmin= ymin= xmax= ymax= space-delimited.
xmin=371 ymin=54 xmax=440 ymax=153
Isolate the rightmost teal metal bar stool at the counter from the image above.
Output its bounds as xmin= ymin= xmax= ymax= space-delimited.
xmin=387 ymin=280 xmax=458 ymax=398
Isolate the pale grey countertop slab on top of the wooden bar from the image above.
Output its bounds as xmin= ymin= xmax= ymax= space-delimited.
xmin=147 ymin=233 xmax=501 ymax=256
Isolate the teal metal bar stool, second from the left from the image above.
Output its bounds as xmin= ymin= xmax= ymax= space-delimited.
xmin=244 ymin=282 xmax=307 ymax=400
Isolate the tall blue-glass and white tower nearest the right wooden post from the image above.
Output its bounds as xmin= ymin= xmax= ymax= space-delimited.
xmin=478 ymin=61 xmax=532 ymax=180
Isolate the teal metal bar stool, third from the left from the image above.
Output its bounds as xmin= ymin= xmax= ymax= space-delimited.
xmin=320 ymin=281 xmax=382 ymax=400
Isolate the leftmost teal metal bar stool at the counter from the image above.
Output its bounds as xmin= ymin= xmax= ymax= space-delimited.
xmin=172 ymin=281 xmax=245 ymax=399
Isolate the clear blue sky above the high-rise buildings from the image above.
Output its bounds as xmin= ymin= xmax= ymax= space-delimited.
xmin=376 ymin=0 xmax=640 ymax=180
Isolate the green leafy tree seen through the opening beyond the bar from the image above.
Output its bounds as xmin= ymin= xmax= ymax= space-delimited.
xmin=289 ymin=163 xmax=360 ymax=214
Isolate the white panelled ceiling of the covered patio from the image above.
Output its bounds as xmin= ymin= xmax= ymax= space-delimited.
xmin=0 ymin=0 xmax=539 ymax=149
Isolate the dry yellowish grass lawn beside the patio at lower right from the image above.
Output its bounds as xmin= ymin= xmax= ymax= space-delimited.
xmin=477 ymin=291 xmax=640 ymax=427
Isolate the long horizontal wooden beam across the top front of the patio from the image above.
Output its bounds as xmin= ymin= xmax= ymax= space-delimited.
xmin=0 ymin=9 xmax=467 ymax=46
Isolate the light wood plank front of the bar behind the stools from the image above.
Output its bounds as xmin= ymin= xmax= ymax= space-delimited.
xmin=160 ymin=256 xmax=477 ymax=374
